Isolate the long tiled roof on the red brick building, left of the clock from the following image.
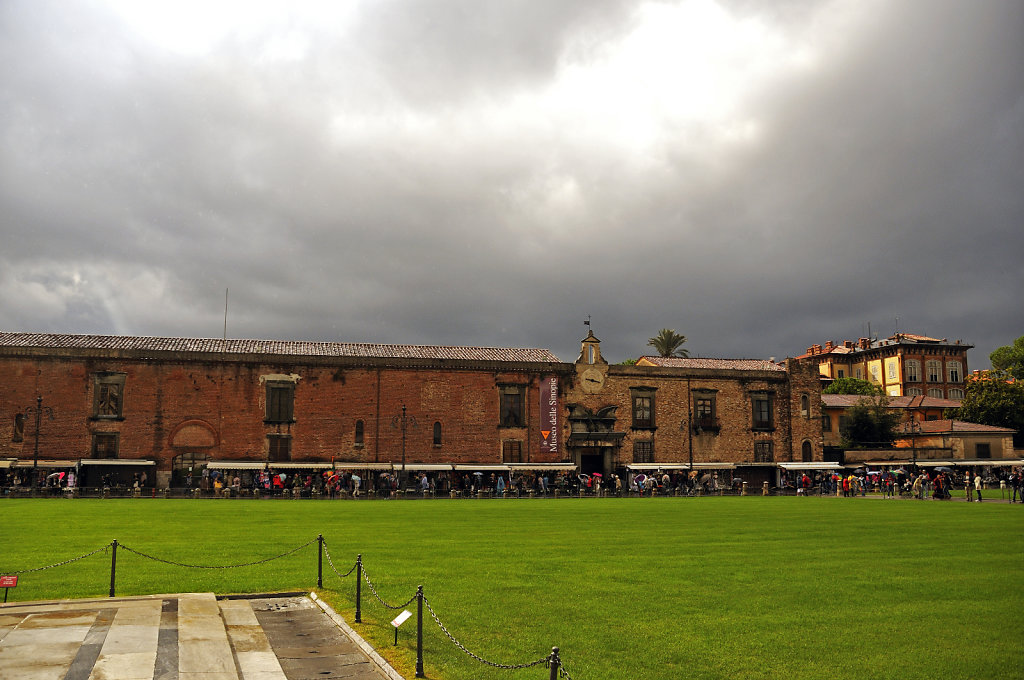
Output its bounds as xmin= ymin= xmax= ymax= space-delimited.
xmin=0 ymin=332 xmax=559 ymax=363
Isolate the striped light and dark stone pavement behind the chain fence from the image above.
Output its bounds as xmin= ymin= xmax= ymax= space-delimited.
xmin=0 ymin=593 xmax=401 ymax=680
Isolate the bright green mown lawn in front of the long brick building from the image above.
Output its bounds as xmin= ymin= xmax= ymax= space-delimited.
xmin=0 ymin=497 xmax=1024 ymax=680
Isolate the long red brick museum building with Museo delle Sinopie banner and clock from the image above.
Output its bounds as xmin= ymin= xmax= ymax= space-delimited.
xmin=0 ymin=333 xmax=821 ymax=486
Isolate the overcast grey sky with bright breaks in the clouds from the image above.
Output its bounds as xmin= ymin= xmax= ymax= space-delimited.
xmin=0 ymin=0 xmax=1024 ymax=368
